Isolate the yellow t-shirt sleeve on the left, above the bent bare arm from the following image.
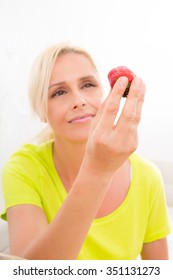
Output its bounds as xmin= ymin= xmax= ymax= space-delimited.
xmin=1 ymin=151 xmax=42 ymax=220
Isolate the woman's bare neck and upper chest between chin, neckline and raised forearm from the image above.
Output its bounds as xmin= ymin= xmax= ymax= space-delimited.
xmin=53 ymin=139 xmax=86 ymax=189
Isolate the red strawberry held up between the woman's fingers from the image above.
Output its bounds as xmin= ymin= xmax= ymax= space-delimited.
xmin=108 ymin=66 xmax=136 ymax=97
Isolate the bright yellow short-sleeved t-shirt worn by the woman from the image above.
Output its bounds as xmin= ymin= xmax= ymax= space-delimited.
xmin=1 ymin=142 xmax=171 ymax=260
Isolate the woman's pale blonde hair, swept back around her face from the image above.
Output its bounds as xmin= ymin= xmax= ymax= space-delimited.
xmin=28 ymin=43 xmax=98 ymax=142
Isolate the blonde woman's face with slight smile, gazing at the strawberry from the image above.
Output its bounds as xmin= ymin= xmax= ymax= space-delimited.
xmin=47 ymin=53 xmax=103 ymax=141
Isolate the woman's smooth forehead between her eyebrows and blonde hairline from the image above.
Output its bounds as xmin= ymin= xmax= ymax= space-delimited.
xmin=50 ymin=53 xmax=96 ymax=84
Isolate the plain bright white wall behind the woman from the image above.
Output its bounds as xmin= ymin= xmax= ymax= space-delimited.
xmin=0 ymin=0 xmax=173 ymax=208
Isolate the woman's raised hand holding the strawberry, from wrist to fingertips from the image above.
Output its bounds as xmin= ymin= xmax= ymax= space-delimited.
xmin=86 ymin=74 xmax=145 ymax=173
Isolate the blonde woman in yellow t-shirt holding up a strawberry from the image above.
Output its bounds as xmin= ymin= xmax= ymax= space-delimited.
xmin=2 ymin=42 xmax=170 ymax=260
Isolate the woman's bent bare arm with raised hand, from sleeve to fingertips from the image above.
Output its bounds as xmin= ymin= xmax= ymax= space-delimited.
xmin=8 ymin=75 xmax=145 ymax=259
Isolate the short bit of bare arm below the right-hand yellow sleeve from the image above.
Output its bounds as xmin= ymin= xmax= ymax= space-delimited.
xmin=141 ymin=238 xmax=169 ymax=260
